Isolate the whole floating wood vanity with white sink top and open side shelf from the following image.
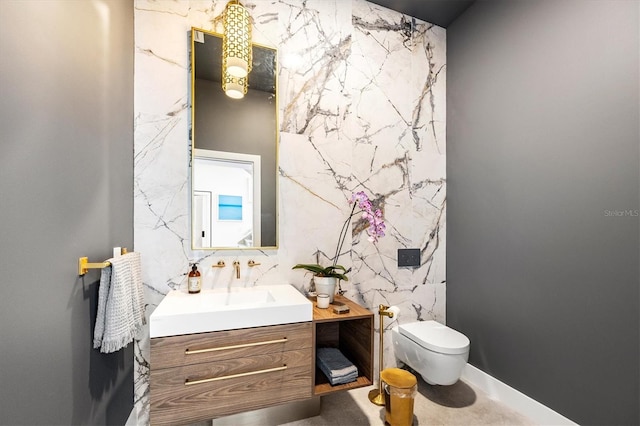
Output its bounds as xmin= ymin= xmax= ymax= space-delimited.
xmin=150 ymin=285 xmax=373 ymax=425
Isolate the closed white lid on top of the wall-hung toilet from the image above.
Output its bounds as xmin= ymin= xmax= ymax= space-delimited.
xmin=398 ymin=320 xmax=469 ymax=354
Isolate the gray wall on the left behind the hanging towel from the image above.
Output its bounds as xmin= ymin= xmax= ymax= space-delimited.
xmin=0 ymin=0 xmax=133 ymax=425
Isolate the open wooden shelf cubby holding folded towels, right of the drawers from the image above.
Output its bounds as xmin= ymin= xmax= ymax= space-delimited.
xmin=313 ymin=295 xmax=374 ymax=396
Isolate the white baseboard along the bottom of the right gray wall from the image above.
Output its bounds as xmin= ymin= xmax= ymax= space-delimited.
xmin=462 ymin=364 xmax=577 ymax=425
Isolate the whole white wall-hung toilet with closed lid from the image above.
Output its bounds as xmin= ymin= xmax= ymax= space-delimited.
xmin=391 ymin=320 xmax=469 ymax=385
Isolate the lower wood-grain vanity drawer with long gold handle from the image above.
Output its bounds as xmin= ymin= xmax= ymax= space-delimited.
xmin=150 ymin=347 xmax=312 ymax=425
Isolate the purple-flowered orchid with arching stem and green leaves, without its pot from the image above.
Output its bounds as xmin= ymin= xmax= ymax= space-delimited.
xmin=293 ymin=191 xmax=386 ymax=281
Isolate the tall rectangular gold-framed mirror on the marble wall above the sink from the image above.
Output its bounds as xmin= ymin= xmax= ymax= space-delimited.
xmin=191 ymin=28 xmax=278 ymax=249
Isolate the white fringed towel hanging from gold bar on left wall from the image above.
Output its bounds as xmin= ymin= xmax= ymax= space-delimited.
xmin=93 ymin=252 xmax=146 ymax=353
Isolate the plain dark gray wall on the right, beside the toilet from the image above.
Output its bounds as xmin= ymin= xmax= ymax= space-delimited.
xmin=447 ymin=0 xmax=640 ymax=425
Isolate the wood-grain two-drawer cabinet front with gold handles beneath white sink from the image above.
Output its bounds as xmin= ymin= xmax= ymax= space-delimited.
xmin=150 ymin=322 xmax=314 ymax=425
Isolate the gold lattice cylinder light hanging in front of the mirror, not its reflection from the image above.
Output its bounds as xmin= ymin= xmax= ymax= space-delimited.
xmin=222 ymin=0 xmax=252 ymax=78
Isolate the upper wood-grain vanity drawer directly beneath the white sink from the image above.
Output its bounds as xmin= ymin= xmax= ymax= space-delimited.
xmin=151 ymin=322 xmax=312 ymax=369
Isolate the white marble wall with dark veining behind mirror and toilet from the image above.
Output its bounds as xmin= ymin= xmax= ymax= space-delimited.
xmin=134 ymin=0 xmax=446 ymax=424
